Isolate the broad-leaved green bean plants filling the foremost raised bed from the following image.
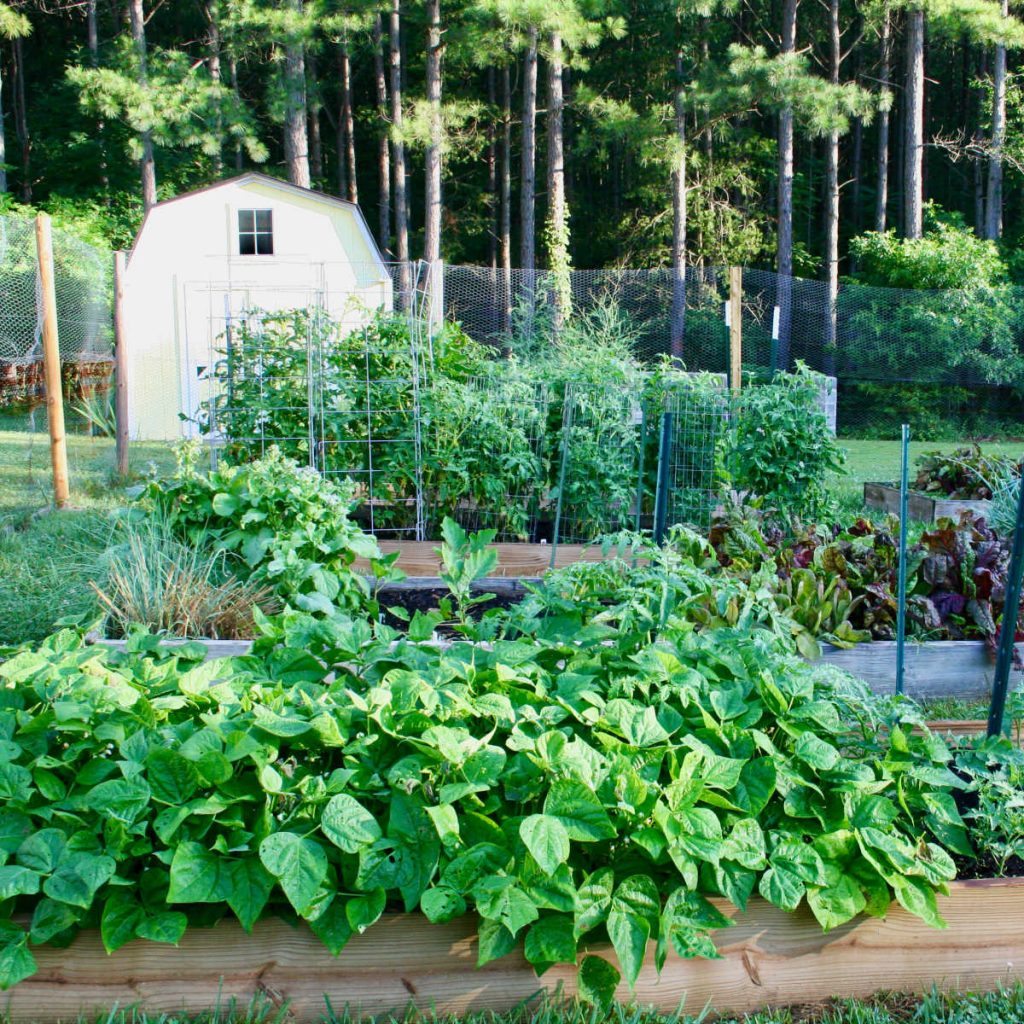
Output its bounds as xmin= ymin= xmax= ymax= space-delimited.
xmin=0 ymin=538 xmax=972 ymax=999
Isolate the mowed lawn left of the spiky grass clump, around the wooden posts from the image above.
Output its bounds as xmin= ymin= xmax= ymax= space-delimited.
xmin=0 ymin=416 xmax=174 ymax=644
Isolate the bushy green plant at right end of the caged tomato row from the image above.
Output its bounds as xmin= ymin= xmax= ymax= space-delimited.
xmin=720 ymin=366 xmax=846 ymax=521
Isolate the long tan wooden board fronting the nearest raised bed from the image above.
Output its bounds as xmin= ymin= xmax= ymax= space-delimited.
xmin=8 ymin=879 xmax=1024 ymax=1024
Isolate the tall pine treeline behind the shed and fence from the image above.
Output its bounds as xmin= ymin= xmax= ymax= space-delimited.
xmin=0 ymin=0 xmax=1024 ymax=283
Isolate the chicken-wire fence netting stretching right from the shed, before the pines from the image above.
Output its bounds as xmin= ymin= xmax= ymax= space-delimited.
xmin=444 ymin=266 xmax=1024 ymax=439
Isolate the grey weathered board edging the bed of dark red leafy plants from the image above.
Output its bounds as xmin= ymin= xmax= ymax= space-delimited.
xmin=821 ymin=640 xmax=1024 ymax=699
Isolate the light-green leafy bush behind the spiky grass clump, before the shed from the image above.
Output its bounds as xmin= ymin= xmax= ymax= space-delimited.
xmin=136 ymin=444 xmax=385 ymax=614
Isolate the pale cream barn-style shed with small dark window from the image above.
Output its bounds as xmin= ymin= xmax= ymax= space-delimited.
xmin=124 ymin=173 xmax=392 ymax=440
